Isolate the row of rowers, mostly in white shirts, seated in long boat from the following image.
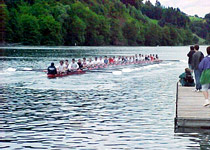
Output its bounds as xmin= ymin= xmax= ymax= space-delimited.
xmin=48 ymin=54 xmax=158 ymax=73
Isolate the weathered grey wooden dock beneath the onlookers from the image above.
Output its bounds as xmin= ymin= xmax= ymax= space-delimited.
xmin=175 ymin=84 xmax=210 ymax=132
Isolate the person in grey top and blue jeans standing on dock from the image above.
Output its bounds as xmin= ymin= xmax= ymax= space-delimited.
xmin=192 ymin=45 xmax=204 ymax=92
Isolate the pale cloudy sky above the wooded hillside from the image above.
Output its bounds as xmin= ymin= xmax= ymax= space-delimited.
xmin=144 ymin=0 xmax=210 ymax=17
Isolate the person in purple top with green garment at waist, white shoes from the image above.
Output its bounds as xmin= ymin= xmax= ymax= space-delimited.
xmin=199 ymin=46 xmax=210 ymax=106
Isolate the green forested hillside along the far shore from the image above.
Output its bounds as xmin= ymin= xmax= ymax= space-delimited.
xmin=0 ymin=0 xmax=210 ymax=46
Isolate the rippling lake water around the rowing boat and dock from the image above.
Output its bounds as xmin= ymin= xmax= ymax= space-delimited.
xmin=0 ymin=46 xmax=210 ymax=150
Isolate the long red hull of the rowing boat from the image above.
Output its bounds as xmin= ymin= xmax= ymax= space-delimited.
xmin=47 ymin=60 xmax=162 ymax=78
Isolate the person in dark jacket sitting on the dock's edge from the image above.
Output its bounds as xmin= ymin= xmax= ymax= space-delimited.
xmin=179 ymin=68 xmax=195 ymax=86
